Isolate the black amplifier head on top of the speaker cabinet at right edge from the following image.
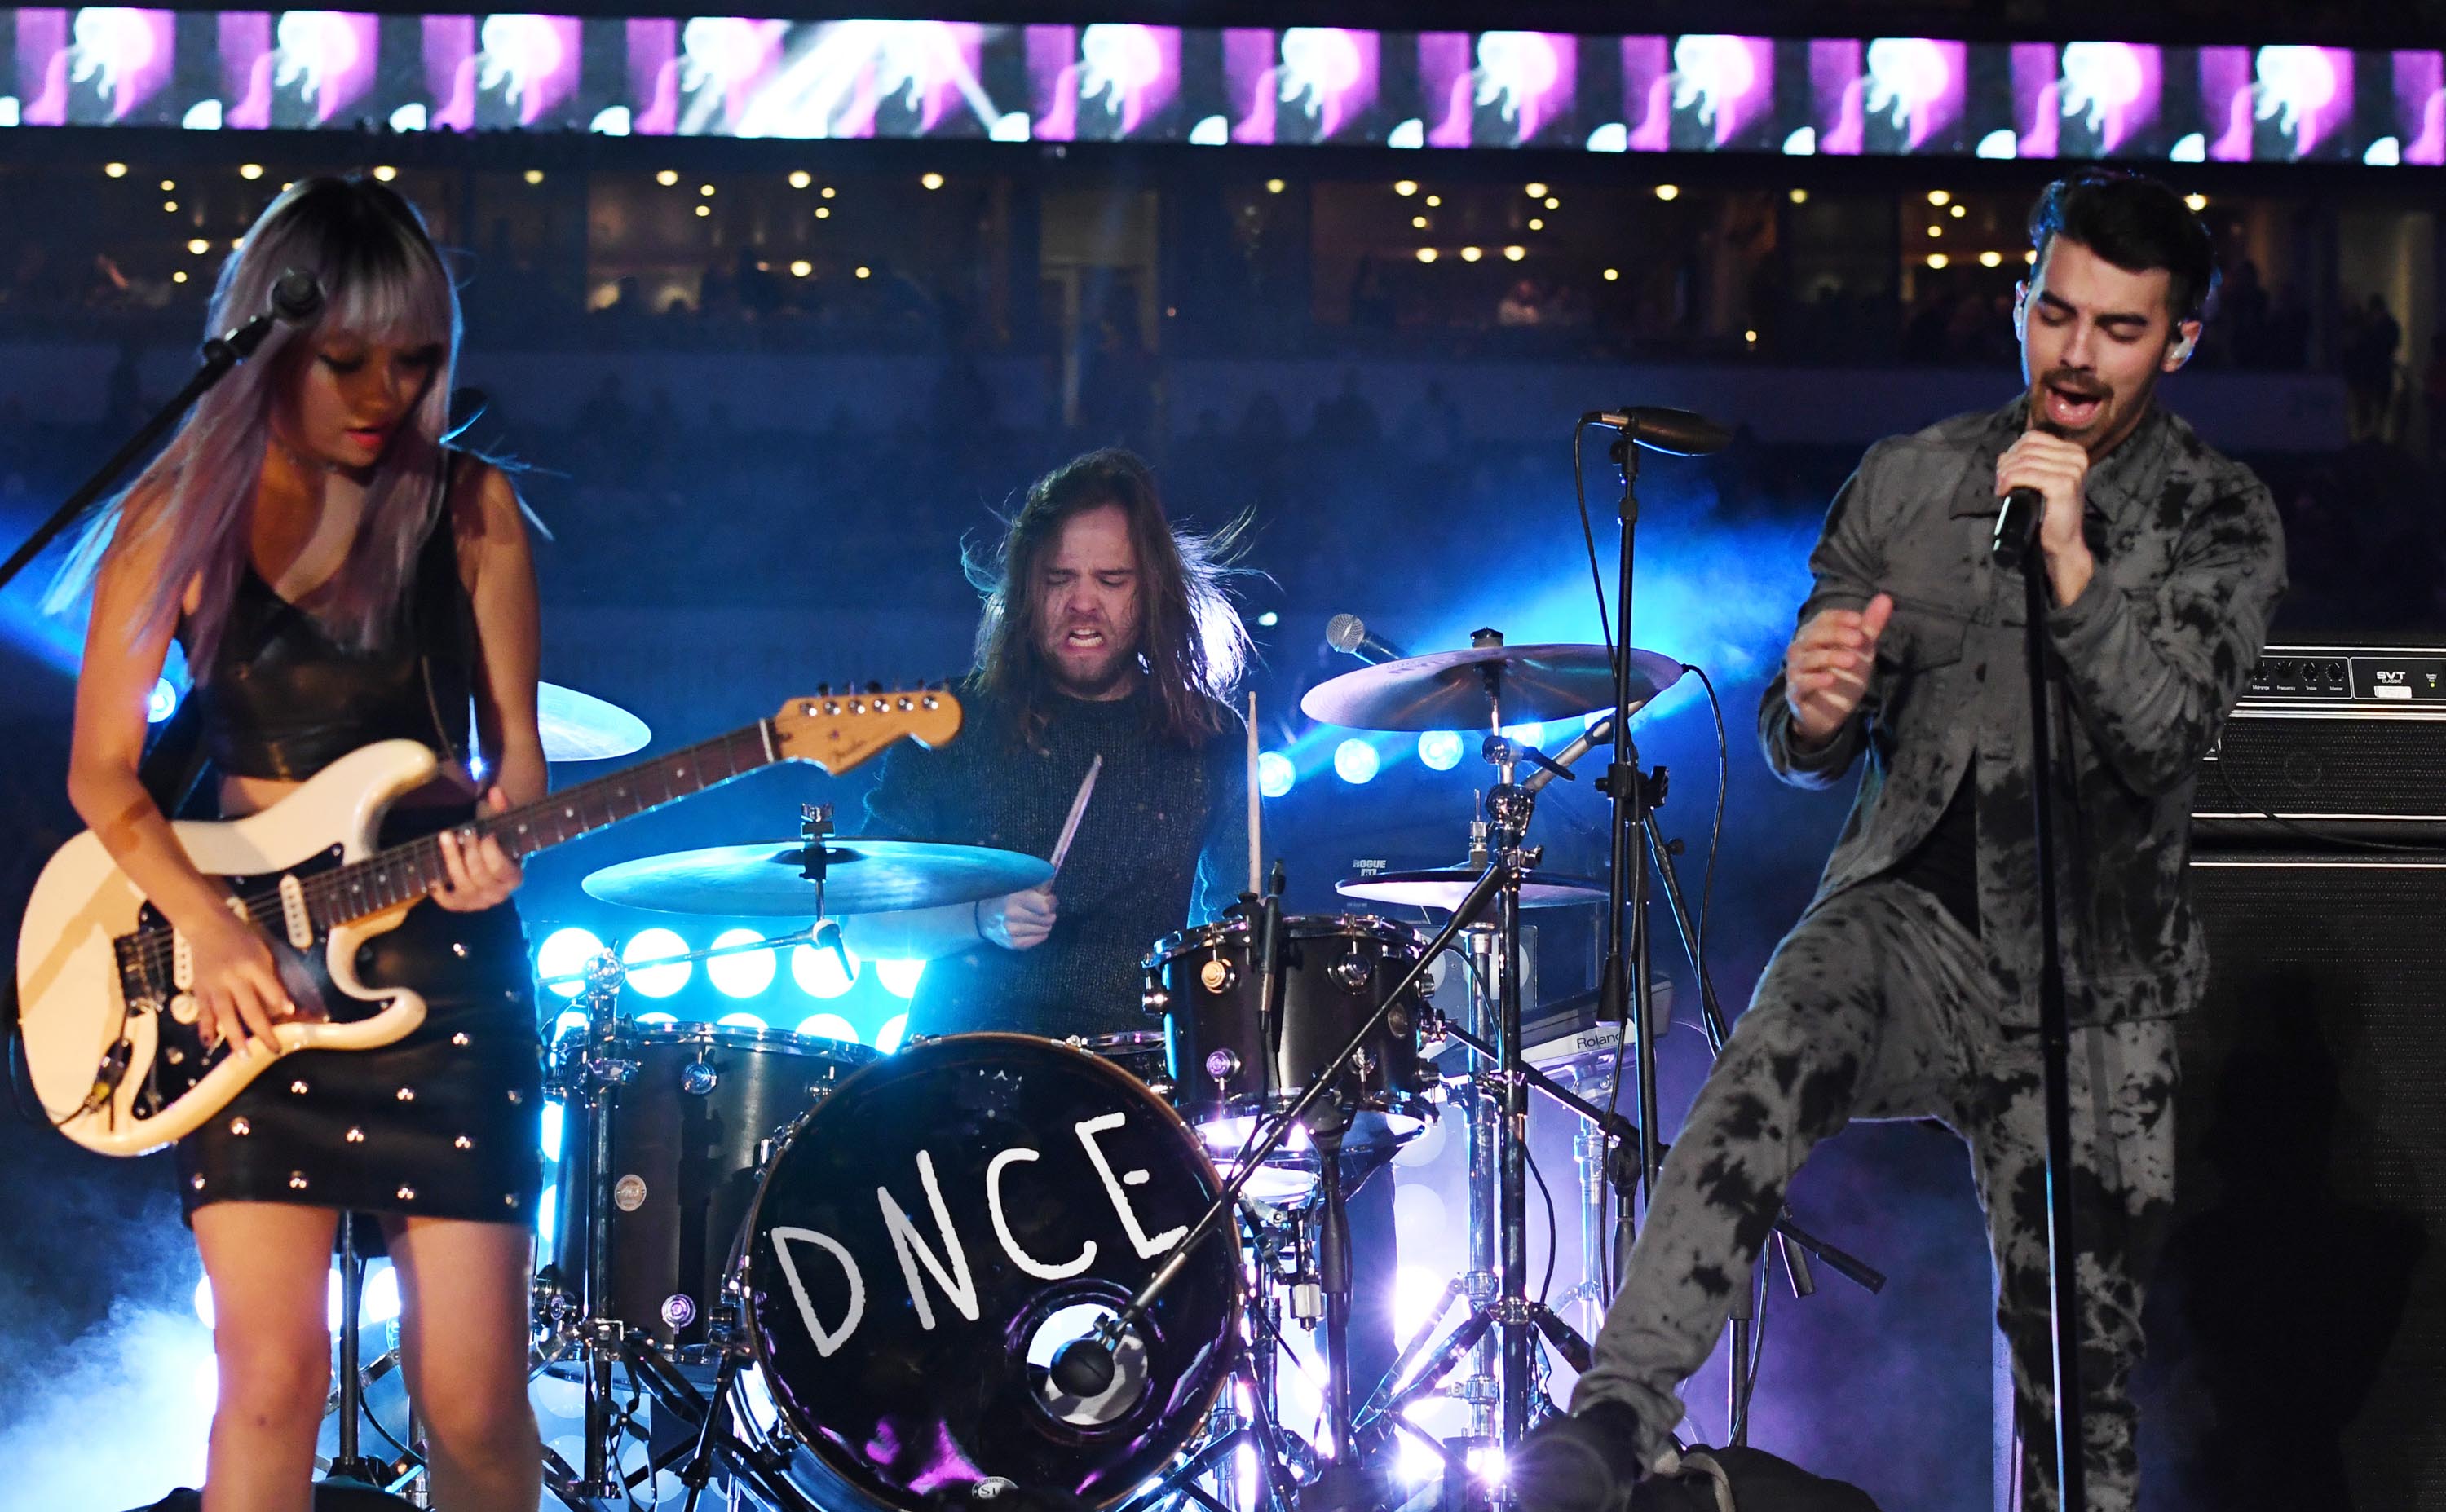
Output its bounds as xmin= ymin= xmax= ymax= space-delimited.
xmin=2192 ymin=646 xmax=2446 ymax=849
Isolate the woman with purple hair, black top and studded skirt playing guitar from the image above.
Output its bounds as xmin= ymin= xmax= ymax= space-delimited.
xmin=68 ymin=179 xmax=545 ymax=1512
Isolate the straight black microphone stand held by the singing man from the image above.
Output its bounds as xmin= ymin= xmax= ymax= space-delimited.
xmin=1996 ymin=538 xmax=2089 ymax=1512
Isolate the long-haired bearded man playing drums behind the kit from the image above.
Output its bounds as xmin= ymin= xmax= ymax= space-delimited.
xmin=844 ymin=450 xmax=1247 ymax=1038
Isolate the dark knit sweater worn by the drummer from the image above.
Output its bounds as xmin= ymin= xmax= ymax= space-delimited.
xmin=863 ymin=690 xmax=1247 ymax=1038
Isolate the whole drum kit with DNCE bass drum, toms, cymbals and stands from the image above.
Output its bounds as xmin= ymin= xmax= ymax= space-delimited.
xmin=316 ymin=619 xmax=1876 ymax=1512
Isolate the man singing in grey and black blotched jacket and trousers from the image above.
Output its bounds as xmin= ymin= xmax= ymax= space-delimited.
xmin=1512 ymin=171 xmax=2285 ymax=1512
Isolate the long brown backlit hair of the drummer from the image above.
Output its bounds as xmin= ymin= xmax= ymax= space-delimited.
xmin=964 ymin=447 xmax=1250 ymax=746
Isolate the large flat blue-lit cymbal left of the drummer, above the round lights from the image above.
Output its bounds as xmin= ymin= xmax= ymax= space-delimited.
xmin=585 ymin=840 xmax=1054 ymax=918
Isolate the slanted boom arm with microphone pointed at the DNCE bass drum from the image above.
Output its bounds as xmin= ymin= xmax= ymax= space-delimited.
xmin=1052 ymin=847 xmax=1539 ymax=1497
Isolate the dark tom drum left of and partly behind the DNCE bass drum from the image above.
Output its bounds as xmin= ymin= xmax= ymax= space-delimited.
xmin=553 ymin=1023 xmax=876 ymax=1363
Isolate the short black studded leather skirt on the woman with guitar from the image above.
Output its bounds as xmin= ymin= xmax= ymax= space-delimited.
xmin=176 ymin=901 xmax=543 ymax=1223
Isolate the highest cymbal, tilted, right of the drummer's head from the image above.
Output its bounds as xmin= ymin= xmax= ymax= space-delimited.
xmin=1299 ymin=643 xmax=1680 ymax=729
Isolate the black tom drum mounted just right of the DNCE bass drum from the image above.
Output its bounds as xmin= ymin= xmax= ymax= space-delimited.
xmin=1145 ymin=913 xmax=1433 ymax=1157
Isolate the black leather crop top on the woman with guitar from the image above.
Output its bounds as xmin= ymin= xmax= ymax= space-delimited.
xmin=179 ymin=467 xmax=477 ymax=781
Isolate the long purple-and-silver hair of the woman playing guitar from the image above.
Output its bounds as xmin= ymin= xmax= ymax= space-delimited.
xmin=49 ymin=176 xmax=460 ymax=675
